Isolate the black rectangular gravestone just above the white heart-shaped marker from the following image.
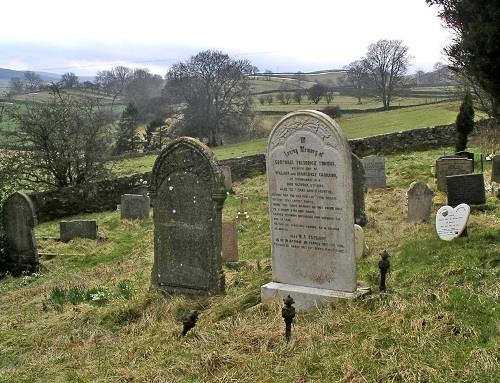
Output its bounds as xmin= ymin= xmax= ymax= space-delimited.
xmin=446 ymin=173 xmax=486 ymax=206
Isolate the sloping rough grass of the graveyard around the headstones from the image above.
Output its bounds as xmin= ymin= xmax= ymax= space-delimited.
xmin=0 ymin=151 xmax=500 ymax=382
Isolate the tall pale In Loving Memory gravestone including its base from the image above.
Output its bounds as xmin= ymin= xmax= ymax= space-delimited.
xmin=261 ymin=110 xmax=365 ymax=311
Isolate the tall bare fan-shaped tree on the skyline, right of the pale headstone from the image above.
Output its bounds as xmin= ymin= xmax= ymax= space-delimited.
xmin=363 ymin=40 xmax=411 ymax=109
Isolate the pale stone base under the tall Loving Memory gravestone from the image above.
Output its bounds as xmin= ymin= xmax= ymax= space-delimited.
xmin=260 ymin=282 xmax=370 ymax=311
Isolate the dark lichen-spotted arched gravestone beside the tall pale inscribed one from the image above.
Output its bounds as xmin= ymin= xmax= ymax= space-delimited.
xmin=150 ymin=137 xmax=226 ymax=294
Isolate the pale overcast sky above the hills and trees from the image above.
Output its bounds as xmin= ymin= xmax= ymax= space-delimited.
xmin=0 ymin=0 xmax=450 ymax=75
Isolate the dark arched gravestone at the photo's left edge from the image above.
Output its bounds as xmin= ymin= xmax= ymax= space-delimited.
xmin=2 ymin=192 xmax=39 ymax=276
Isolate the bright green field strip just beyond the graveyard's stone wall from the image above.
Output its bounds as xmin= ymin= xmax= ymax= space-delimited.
xmin=112 ymin=102 xmax=470 ymax=175
